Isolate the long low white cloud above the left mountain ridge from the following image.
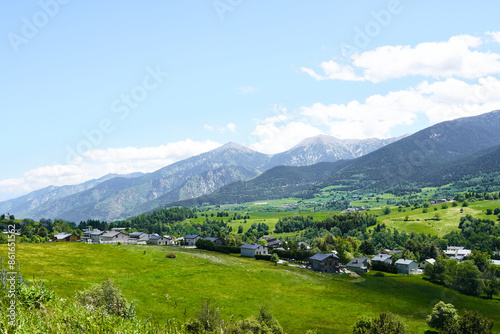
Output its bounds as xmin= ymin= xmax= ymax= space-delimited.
xmin=0 ymin=139 xmax=220 ymax=198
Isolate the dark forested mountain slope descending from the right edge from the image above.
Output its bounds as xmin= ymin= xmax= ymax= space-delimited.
xmin=170 ymin=110 xmax=500 ymax=206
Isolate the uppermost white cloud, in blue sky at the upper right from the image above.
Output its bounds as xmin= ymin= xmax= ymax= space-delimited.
xmin=301 ymin=33 xmax=500 ymax=83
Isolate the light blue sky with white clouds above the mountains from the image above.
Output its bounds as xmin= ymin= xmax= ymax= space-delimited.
xmin=0 ymin=0 xmax=500 ymax=201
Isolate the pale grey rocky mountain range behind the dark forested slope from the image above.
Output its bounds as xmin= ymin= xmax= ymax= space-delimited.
xmin=0 ymin=135 xmax=399 ymax=221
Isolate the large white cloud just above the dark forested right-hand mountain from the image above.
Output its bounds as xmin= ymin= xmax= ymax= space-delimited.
xmin=302 ymin=77 xmax=500 ymax=139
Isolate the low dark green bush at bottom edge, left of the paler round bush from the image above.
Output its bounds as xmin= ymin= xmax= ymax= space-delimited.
xmin=352 ymin=312 xmax=406 ymax=334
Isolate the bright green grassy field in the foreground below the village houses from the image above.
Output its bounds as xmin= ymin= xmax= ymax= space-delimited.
xmin=4 ymin=243 xmax=500 ymax=333
